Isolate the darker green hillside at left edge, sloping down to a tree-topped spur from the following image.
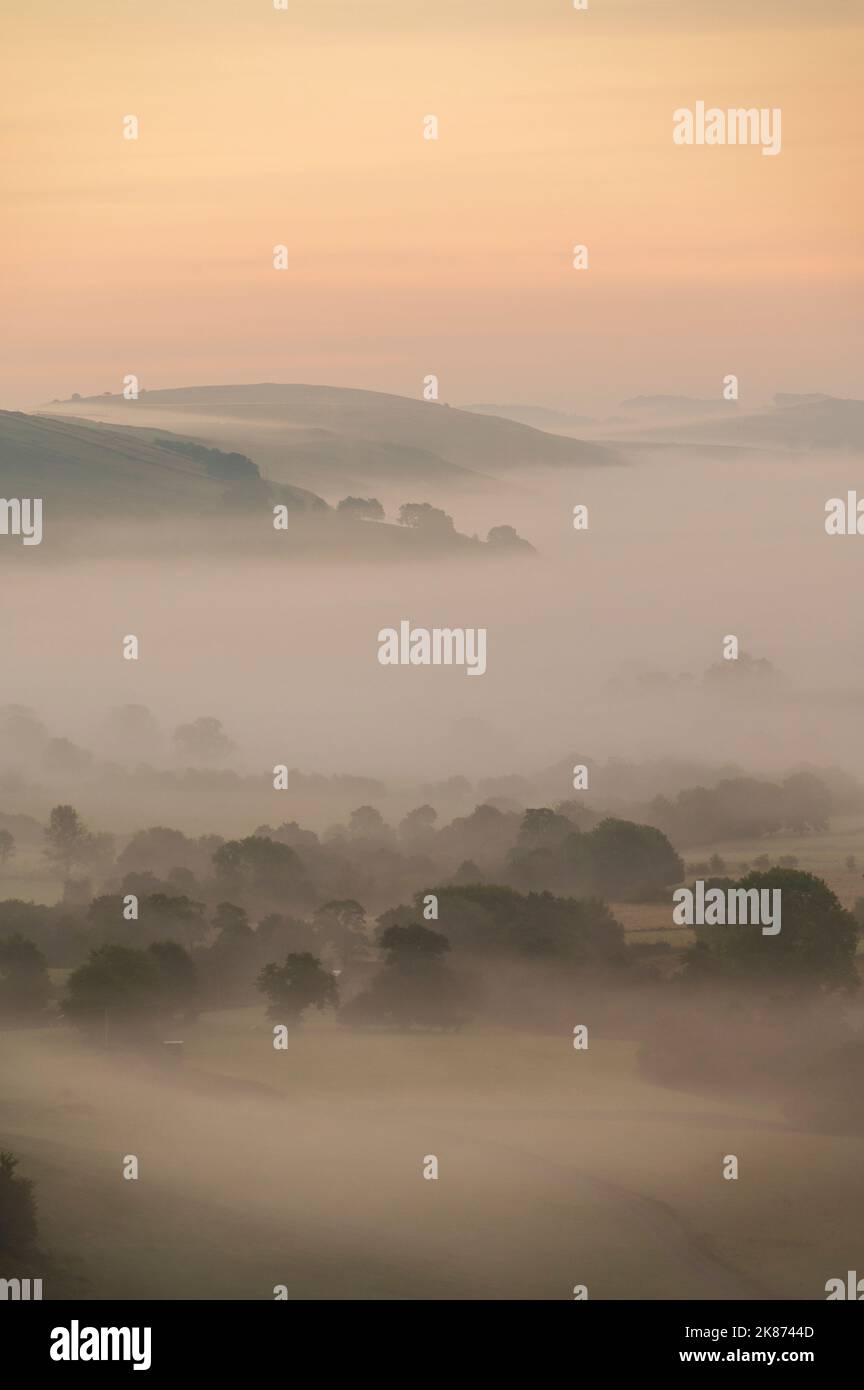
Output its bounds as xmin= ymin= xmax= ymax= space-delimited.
xmin=0 ymin=410 xmax=533 ymax=560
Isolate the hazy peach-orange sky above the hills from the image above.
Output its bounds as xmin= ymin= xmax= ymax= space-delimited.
xmin=0 ymin=0 xmax=864 ymax=410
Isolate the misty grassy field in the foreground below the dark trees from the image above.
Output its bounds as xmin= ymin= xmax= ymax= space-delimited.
xmin=0 ymin=1008 xmax=864 ymax=1300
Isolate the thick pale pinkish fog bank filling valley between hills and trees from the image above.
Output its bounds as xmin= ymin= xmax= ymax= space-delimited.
xmin=0 ymin=448 xmax=864 ymax=795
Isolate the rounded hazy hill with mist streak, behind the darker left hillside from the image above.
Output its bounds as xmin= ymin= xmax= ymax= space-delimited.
xmin=37 ymin=382 xmax=615 ymax=496
